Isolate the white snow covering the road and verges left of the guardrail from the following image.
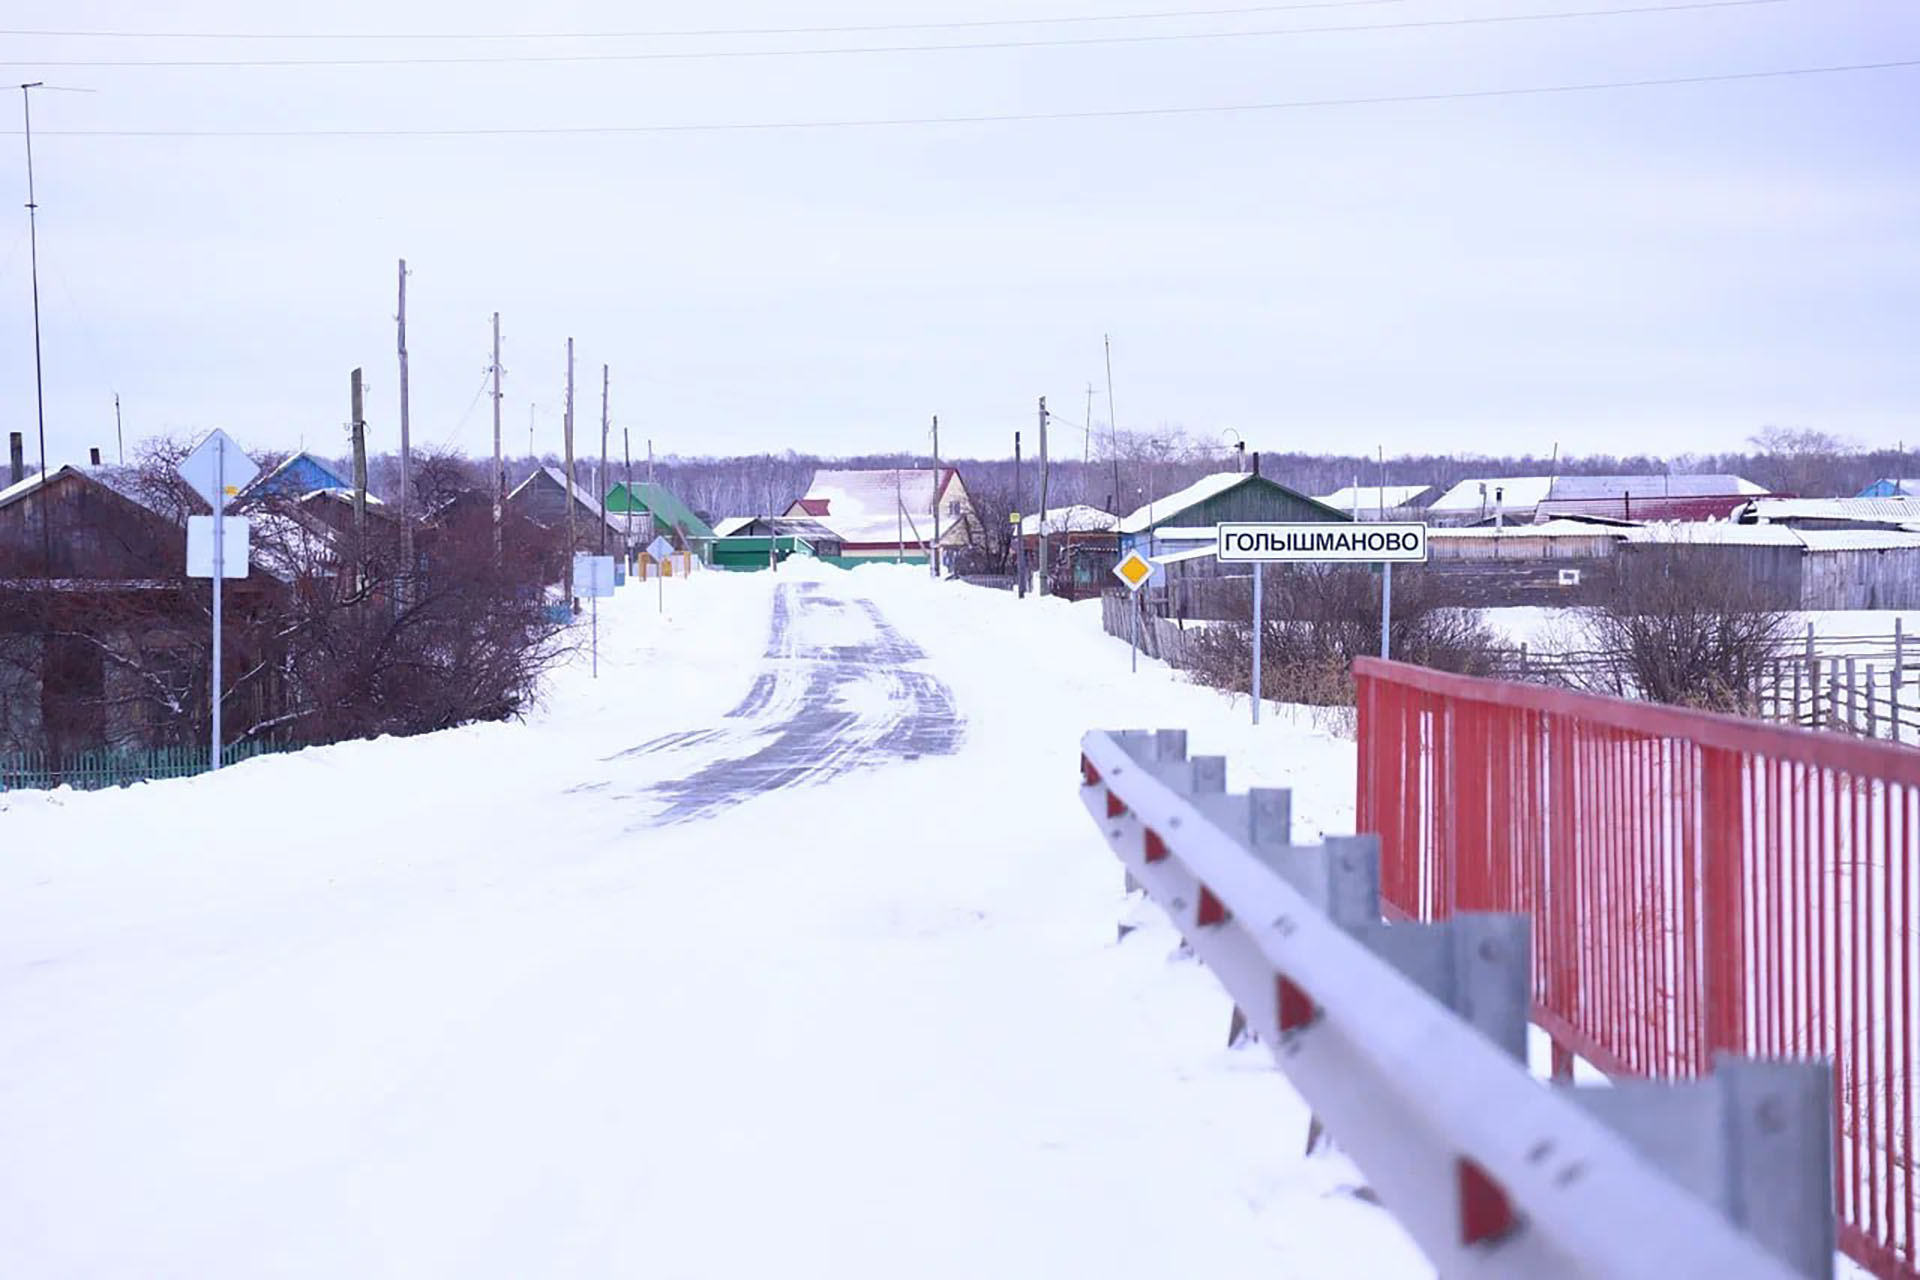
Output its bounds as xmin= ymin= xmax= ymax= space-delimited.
xmin=0 ymin=566 xmax=1427 ymax=1280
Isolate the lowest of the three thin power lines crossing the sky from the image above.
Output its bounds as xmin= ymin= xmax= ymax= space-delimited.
xmin=8 ymin=58 xmax=1920 ymax=138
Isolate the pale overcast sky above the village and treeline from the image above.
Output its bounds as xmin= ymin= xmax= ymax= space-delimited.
xmin=0 ymin=0 xmax=1920 ymax=464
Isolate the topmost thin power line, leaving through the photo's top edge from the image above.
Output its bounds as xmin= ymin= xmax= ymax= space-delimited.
xmin=0 ymin=0 xmax=1405 ymax=40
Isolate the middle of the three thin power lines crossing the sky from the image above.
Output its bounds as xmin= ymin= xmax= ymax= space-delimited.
xmin=13 ymin=0 xmax=1788 ymax=71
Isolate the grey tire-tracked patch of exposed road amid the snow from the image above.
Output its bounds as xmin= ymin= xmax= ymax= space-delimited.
xmin=612 ymin=583 xmax=966 ymax=823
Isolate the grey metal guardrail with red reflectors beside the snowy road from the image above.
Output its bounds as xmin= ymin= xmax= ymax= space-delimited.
xmin=1081 ymin=729 xmax=1834 ymax=1280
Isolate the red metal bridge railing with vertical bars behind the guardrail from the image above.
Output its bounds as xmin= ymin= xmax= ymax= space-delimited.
xmin=1354 ymin=658 xmax=1920 ymax=1280
